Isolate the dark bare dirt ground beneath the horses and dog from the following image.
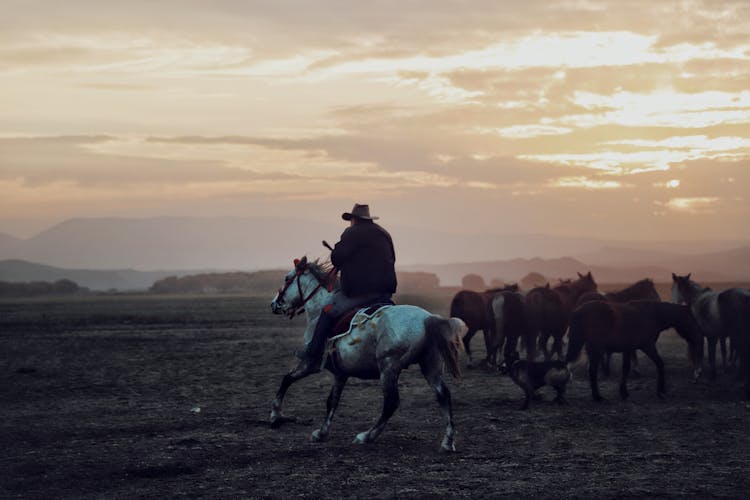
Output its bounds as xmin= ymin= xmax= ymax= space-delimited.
xmin=0 ymin=296 xmax=750 ymax=498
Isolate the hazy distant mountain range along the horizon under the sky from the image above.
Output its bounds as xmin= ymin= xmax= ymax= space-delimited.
xmin=0 ymin=217 xmax=750 ymax=290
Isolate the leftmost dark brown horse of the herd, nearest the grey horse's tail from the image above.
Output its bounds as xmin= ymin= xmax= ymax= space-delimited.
xmin=450 ymin=284 xmax=518 ymax=367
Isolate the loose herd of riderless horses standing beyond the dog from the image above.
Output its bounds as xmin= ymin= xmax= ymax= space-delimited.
xmin=450 ymin=272 xmax=750 ymax=401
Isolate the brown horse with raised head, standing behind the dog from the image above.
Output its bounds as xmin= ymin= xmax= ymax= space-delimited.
xmin=524 ymin=272 xmax=596 ymax=360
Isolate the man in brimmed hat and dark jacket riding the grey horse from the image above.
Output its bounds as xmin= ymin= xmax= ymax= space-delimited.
xmin=298 ymin=204 xmax=397 ymax=372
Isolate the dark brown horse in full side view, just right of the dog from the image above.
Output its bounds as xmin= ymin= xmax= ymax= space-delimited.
xmin=565 ymin=300 xmax=703 ymax=401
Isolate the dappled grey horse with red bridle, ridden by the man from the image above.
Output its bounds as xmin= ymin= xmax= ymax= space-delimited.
xmin=271 ymin=257 xmax=466 ymax=451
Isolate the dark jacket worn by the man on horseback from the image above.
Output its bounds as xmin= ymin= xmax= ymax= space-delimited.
xmin=331 ymin=221 xmax=396 ymax=297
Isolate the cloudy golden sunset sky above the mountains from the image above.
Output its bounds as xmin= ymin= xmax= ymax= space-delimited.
xmin=0 ymin=0 xmax=750 ymax=240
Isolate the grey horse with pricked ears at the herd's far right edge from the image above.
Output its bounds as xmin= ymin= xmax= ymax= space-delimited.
xmin=672 ymin=273 xmax=750 ymax=399
